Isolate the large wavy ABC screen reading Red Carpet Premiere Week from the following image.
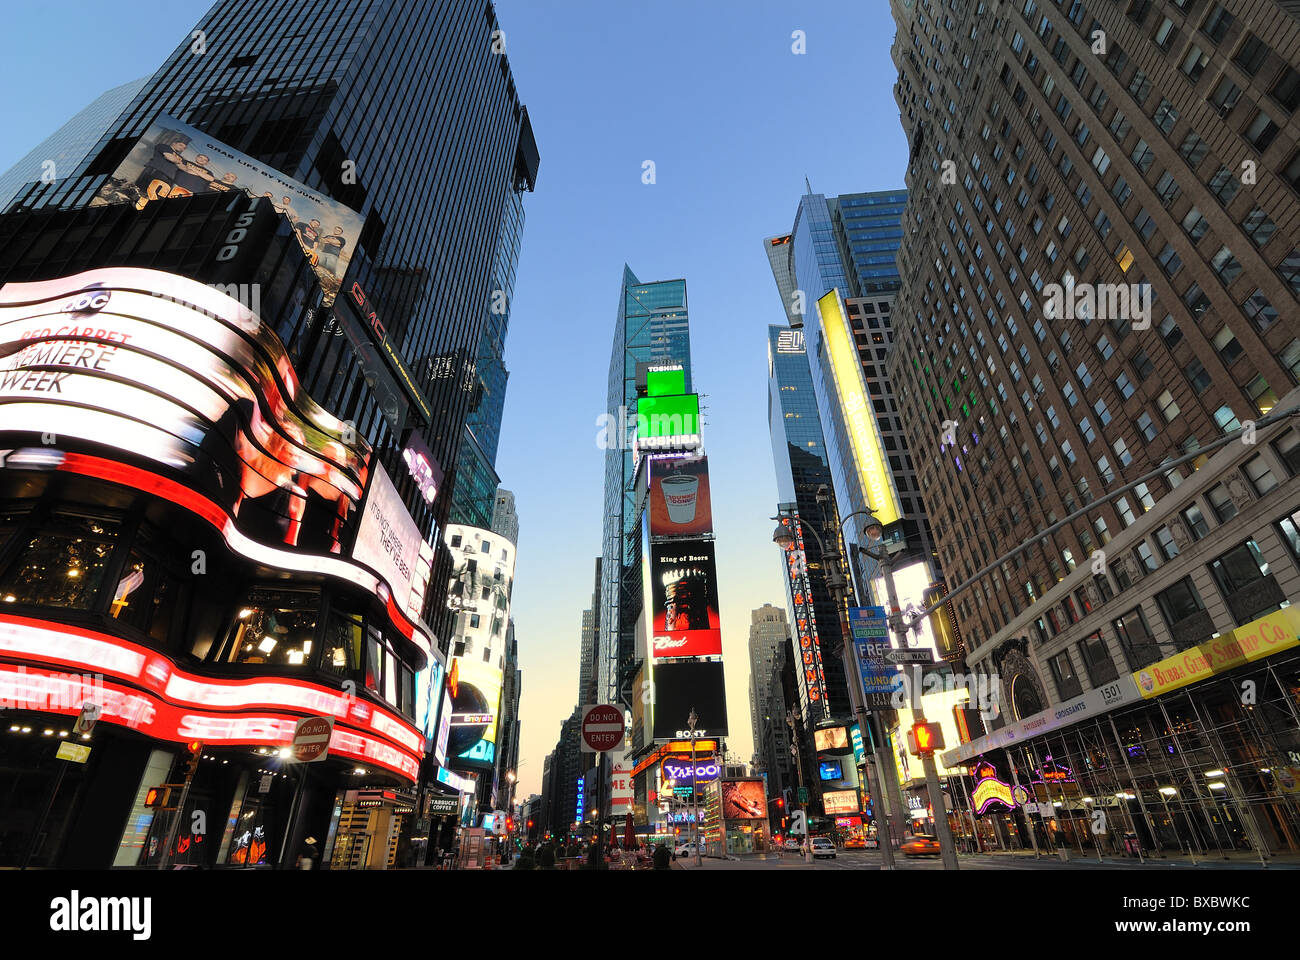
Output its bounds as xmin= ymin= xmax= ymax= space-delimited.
xmin=0 ymin=267 xmax=371 ymax=554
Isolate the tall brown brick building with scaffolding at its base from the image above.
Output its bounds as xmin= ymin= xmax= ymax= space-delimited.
xmin=887 ymin=0 xmax=1300 ymax=856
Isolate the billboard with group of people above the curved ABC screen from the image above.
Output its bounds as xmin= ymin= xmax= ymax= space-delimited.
xmin=90 ymin=116 xmax=364 ymax=306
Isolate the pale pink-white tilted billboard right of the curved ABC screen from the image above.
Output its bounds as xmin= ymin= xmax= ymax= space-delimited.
xmin=352 ymin=463 xmax=429 ymax=618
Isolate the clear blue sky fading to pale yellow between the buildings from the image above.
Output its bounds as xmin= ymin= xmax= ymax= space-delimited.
xmin=0 ymin=0 xmax=907 ymax=797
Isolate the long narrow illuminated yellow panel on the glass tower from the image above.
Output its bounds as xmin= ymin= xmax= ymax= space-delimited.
xmin=816 ymin=290 xmax=902 ymax=526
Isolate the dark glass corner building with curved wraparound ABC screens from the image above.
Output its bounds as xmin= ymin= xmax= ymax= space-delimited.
xmin=0 ymin=0 xmax=537 ymax=869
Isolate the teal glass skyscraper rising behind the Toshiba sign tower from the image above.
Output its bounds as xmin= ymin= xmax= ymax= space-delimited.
xmin=597 ymin=265 xmax=693 ymax=702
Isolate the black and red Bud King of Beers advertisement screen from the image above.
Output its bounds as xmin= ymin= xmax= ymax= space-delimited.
xmin=650 ymin=540 xmax=723 ymax=658
